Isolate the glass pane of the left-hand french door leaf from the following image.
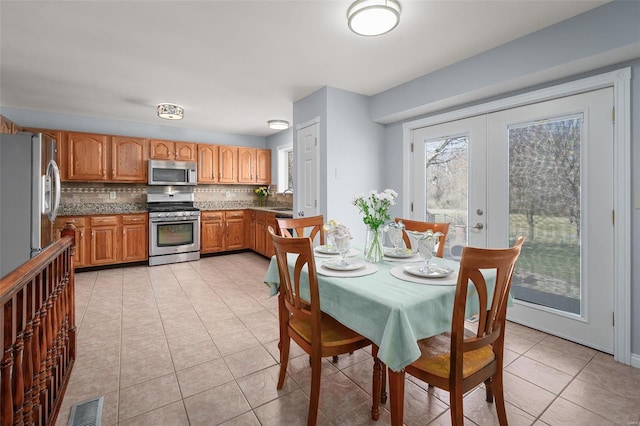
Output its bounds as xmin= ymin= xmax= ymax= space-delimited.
xmin=424 ymin=135 xmax=469 ymax=259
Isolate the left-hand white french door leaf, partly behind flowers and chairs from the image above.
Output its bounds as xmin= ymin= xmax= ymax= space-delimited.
xmin=411 ymin=115 xmax=487 ymax=253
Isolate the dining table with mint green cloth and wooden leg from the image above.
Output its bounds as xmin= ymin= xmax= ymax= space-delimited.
xmin=264 ymin=246 xmax=495 ymax=426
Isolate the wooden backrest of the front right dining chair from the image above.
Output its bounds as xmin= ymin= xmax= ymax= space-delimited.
xmin=451 ymin=237 xmax=525 ymax=379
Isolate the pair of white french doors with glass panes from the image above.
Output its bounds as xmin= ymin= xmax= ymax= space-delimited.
xmin=413 ymin=88 xmax=614 ymax=353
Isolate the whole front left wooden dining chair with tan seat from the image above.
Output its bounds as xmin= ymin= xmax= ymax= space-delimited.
xmin=268 ymin=226 xmax=382 ymax=425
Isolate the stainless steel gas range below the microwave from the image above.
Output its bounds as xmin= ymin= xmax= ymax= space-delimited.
xmin=147 ymin=186 xmax=200 ymax=266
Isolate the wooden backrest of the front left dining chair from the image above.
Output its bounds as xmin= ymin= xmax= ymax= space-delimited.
xmin=268 ymin=226 xmax=320 ymax=336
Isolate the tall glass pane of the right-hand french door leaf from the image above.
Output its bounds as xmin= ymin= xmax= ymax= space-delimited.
xmin=508 ymin=116 xmax=582 ymax=314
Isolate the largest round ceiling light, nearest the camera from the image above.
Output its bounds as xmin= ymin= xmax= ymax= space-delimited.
xmin=347 ymin=0 xmax=400 ymax=36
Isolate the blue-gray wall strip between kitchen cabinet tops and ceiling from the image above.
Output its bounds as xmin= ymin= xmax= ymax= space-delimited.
xmin=0 ymin=107 xmax=267 ymax=148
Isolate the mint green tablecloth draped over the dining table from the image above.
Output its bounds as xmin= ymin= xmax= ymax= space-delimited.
xmin=264 ymin=251 xmax=495 ymax=371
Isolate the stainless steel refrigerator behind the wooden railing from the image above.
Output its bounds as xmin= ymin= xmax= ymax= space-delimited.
xmin=0 ymin=133 xmax=60 ymax=277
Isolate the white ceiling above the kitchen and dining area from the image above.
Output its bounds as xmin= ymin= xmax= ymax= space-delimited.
xmin=0 ymin=0 xmax=608 ymax=136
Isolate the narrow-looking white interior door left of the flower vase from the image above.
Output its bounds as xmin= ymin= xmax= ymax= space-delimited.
xmin=295 ymin=122 xmax=320 ymax=217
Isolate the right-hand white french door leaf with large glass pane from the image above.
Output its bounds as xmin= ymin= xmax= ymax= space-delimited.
xmin=487 ymin=88 xmax=614 ymax=353
